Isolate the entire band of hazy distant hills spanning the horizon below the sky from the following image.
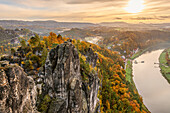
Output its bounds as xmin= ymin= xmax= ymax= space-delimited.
xmin=0 ymin=20 xmax=170 ymax=36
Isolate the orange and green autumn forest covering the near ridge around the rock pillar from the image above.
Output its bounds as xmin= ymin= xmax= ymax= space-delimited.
xmin=1 ymin=32 xmax=149 ymax=113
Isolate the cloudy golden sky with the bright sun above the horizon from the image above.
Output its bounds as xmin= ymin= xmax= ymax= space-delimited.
xmin=0 ymin=0 xmax=170 ymax=23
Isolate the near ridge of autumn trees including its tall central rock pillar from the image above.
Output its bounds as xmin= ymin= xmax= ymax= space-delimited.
xmin=0 ymin=33 xmax=149 ymax=113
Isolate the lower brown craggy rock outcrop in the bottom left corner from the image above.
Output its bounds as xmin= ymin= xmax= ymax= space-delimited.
xmin=0 ymin=62 xmax=37 ymax=113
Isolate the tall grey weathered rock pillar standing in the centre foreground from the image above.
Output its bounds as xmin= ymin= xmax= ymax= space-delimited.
xmin=43 ymin=42 xmax=99 ymax=113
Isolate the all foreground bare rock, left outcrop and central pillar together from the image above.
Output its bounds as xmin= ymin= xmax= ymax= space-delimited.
xmin=0 ymin=42 xmax=100 ymax=113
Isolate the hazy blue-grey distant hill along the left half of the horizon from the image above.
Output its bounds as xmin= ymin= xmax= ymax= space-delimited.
xmin=0 ymin=20 xmax=96 ymax=34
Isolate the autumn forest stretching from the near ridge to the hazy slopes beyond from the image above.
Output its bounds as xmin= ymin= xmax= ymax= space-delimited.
xmin=0 ymin=25 xmax=170 ymax=113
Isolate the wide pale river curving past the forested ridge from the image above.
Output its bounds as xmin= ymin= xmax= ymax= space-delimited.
xmin=133 ymin=49 xmax=170 ymax=113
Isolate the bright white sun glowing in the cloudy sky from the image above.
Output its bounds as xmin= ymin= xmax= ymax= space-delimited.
xmin=124 ymin=0 xmax=145 ymax=13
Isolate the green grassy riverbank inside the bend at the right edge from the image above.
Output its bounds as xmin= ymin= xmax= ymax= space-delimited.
xmin=159 ymin=48 xmax=170 ymax=84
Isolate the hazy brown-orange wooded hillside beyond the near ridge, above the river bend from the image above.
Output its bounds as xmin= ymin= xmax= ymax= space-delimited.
xmin=62 ymin=27 xmax=170 ymax=58
